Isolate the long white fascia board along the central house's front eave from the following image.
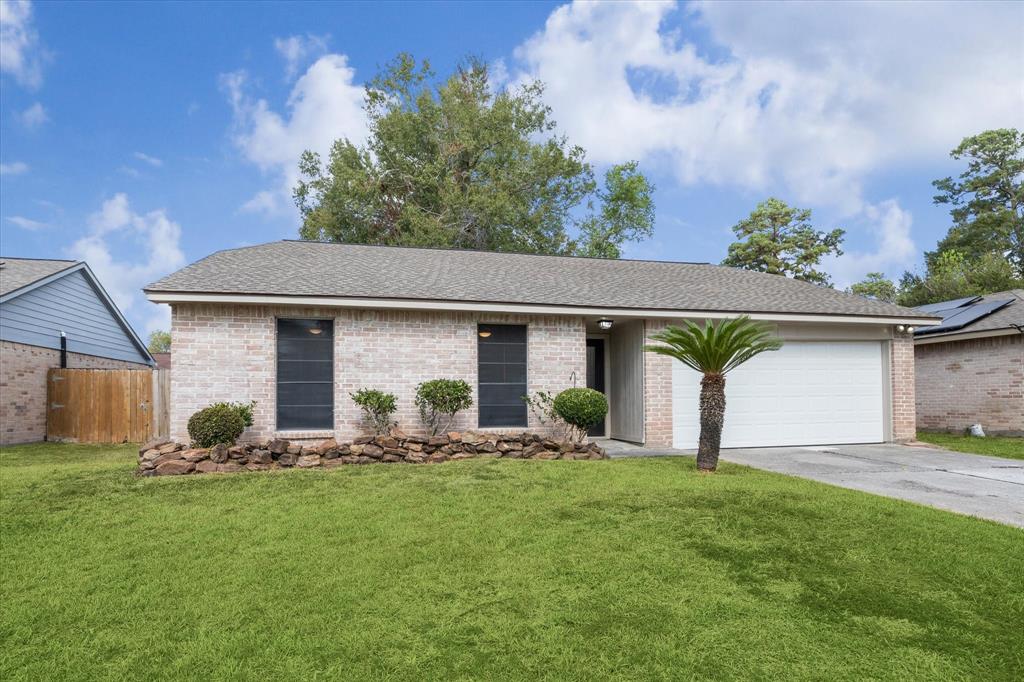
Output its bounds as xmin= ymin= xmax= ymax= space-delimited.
xmin=145 ymin=292 xmax=942 ymax=327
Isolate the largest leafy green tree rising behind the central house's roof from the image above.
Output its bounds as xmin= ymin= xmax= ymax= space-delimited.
xmin=294 ymin=54 xmax=654 ymax=258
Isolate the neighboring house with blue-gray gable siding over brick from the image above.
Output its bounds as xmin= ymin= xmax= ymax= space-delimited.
xmin=0 ymin=258 xmax=153 ymax=445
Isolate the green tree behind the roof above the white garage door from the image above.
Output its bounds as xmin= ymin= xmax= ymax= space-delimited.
xmin=722 ymin=198 xmax=846 ymax=286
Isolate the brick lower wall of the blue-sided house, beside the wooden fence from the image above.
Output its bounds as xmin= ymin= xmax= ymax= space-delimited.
xmin=0 ymin=341 xmax=148 ymax=445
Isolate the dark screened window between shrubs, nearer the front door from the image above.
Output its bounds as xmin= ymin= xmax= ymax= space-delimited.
xmin=476 ymin=325 xmax=526 ymax=427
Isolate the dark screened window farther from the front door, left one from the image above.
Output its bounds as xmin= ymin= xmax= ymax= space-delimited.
xmin=278 ymin=319 xmax=334 ymax=430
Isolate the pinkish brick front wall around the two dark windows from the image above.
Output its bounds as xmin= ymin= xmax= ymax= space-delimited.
xmin=171 ymin=304 xmax=586 ymax=440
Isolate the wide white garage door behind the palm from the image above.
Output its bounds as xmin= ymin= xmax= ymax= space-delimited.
xmin=672 ymin=341 xmax=885 ymax=449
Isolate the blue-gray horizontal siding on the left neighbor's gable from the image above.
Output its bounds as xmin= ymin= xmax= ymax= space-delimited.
xmin=0 ymin=270 xmax=147 ymax=364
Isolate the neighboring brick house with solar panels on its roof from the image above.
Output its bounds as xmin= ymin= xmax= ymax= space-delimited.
xmin=913 ymin=289 xmax=1024 ymax=435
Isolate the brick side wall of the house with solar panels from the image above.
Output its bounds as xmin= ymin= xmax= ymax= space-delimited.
xmin=914 ymin=334 xmax=1024 ymax=435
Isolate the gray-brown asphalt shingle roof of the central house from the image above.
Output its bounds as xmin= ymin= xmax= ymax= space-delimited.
xmin=145 ymin=241 xmax=929 ymax=318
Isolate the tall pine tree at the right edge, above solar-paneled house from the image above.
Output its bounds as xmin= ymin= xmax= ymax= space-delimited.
xmin=926 ymin=128 xmax=1024 ymax=275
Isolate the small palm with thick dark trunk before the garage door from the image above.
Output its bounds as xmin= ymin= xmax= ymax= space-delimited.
xmin=644 ymin=315 xmax=782 ymax=471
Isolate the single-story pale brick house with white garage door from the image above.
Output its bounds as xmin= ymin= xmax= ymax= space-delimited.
xmin=145 ymin=241 xmax=937 ymax=447
